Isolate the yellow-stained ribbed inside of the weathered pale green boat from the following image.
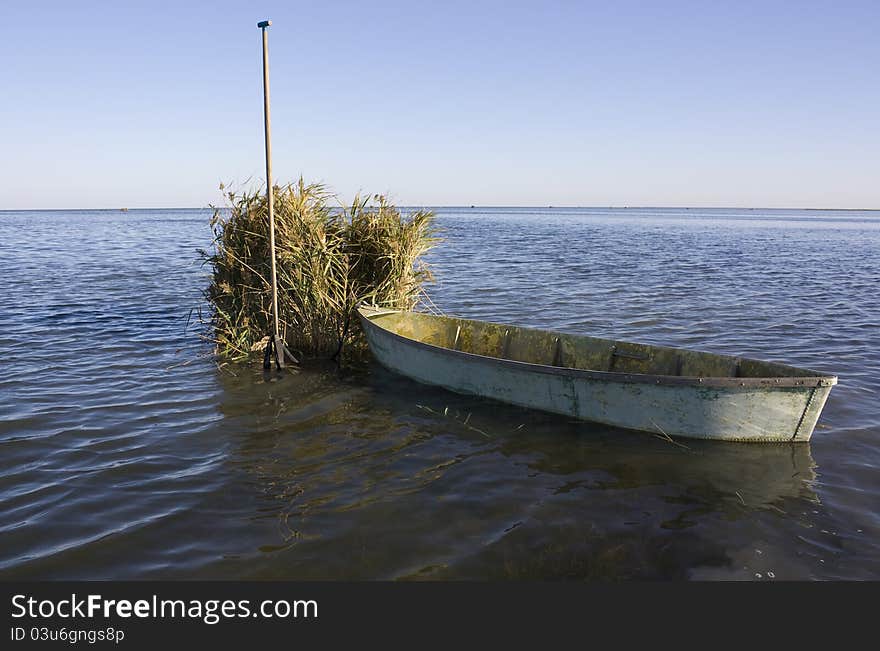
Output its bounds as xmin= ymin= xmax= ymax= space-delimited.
xmin=366 ymin=311 xmax=823 ymax=378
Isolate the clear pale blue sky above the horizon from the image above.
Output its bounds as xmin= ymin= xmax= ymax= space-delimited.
xmin=0 ymin=0 xmax=880 ymax=209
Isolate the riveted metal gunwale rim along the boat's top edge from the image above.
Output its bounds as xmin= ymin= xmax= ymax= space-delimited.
xmin=358 ymin=307 xmax=837 ymax=389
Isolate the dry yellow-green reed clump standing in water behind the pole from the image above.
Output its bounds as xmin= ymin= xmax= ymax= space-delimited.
xmin=204 ymin=179 xmax=437 ymax=359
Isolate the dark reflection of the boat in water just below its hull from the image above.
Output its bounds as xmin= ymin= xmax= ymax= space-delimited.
xmin=371 ymin=369 xmax=818 ymax=508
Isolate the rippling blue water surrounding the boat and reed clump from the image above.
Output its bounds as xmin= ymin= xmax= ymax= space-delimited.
xmin=0 ymin=208 xmax=880 ymax=580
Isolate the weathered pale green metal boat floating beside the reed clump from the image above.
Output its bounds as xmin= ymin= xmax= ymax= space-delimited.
xmin=358 ymin=305 xmax=837 ymax=442
